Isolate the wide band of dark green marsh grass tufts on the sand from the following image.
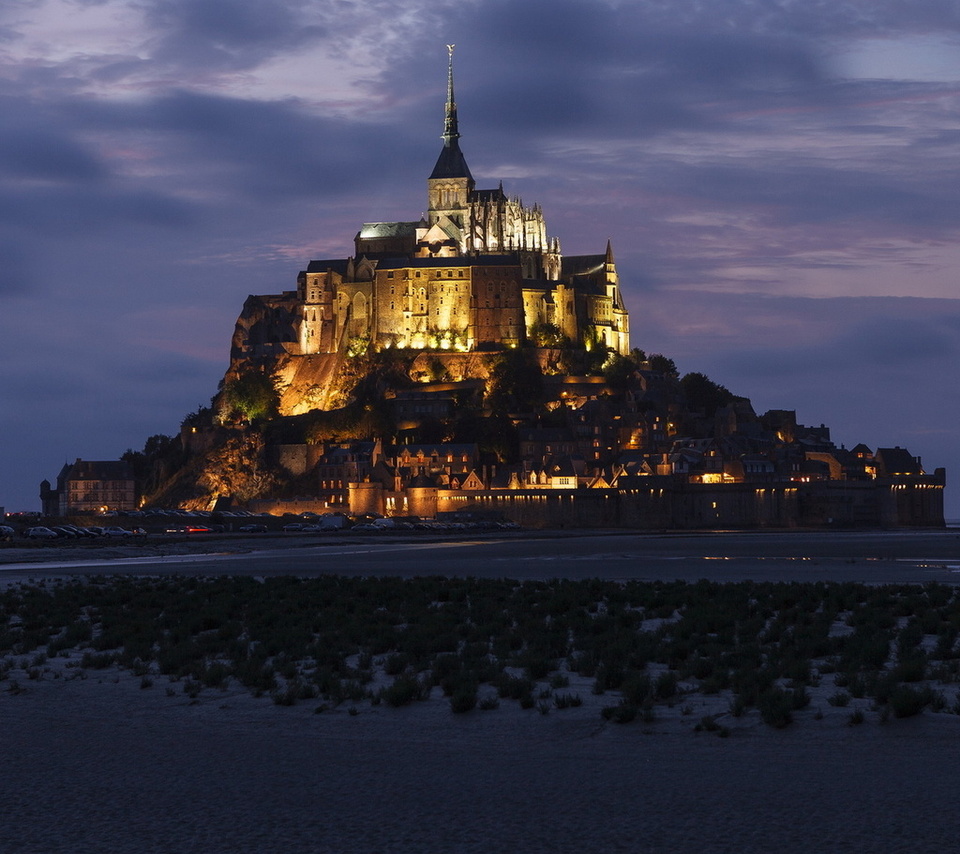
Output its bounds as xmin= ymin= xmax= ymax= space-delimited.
xmin=0 ymin=576 xmax=960 ymax=727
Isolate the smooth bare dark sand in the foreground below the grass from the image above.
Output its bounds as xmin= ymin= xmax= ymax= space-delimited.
xmin=7 ymin=674 xmax=960 ymax=854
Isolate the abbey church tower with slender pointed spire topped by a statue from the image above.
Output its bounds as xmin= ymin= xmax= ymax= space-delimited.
xmin=427 ymin=49 xmax=474 ymax=241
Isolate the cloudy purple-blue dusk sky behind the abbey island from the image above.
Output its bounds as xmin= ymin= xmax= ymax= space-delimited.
xmin=0 ymin=0 xmax=960 ymax=518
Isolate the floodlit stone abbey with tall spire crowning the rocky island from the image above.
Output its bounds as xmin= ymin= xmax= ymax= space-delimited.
xmin=232 ymin=47 xmax=630 ymax=364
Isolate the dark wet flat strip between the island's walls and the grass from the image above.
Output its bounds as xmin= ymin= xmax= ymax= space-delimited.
xmin=0 ymin=529 xmax=960 ymax=584
